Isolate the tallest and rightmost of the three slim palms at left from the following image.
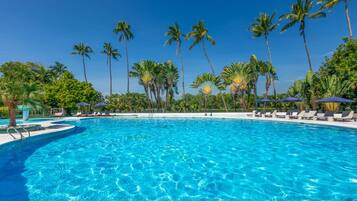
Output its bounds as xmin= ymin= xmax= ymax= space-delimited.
xmin=114 ymin=21 xmax=134 ymax=93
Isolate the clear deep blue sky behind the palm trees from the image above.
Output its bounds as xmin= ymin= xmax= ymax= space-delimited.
xmin=0 ymin=0 xmax=357 ymax=94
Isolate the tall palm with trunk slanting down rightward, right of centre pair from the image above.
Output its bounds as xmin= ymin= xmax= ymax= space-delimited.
xmin=186 ymin=20 xmax=228 ymax=111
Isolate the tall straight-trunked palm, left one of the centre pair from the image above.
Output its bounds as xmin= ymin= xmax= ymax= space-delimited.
xmin=165 ymin=23 xmax=186 ymax=102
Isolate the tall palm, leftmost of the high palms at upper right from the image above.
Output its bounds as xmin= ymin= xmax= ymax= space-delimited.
xmin=249 ymin=13 xmax=278 ymax=63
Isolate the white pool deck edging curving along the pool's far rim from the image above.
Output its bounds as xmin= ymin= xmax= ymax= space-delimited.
xmin=0 ymin=112 xmax=357 ymax=145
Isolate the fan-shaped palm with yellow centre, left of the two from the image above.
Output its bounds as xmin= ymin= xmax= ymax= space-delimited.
xmin=191 ymin=73 xmax=223 ymax=112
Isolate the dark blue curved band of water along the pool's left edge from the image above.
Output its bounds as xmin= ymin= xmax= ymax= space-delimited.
xmin=0 ymin=127 xmax=85 ymax=201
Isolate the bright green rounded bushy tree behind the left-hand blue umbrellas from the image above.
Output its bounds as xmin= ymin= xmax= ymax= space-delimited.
xmin=44 ymin=72 xmax=102 ymax=113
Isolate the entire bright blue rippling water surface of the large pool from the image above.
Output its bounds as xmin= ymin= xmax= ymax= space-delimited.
xmin=0 ymin=119 xmax=357 ymax=201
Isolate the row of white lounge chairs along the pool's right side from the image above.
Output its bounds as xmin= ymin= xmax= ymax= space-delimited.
xmin=248 ymin=110 xmax=357 ymax=121
